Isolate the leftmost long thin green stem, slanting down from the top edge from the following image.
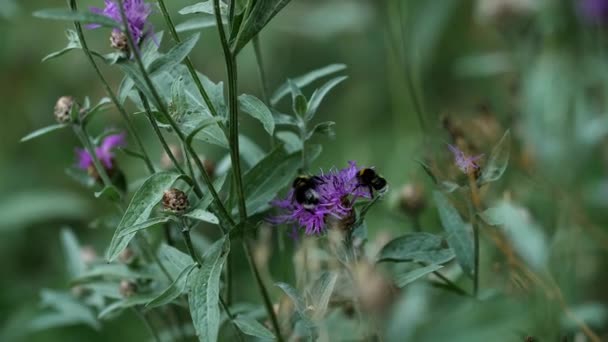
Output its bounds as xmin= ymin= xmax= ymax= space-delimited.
xmin=69 ymin=0 xmax=155 ymax=174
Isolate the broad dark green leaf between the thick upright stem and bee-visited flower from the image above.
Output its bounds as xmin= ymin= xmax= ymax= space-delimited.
xmin=243 ymin=146 xmax=301 ymax=214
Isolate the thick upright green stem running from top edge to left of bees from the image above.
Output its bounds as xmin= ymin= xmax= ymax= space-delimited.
xmin=213 ymin=0 xmax=247 ymax=222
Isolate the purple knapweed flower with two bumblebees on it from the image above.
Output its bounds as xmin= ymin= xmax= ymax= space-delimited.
xmin=270 ymin=162 xmax=372 ymax=235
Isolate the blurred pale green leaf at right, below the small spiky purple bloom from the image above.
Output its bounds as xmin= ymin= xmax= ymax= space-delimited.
xmin=479 ymin=201 xmax=549 ymax=269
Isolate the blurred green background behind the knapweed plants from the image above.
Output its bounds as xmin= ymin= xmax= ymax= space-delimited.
xmin=0 ymin=0 xmax=608 ymax=341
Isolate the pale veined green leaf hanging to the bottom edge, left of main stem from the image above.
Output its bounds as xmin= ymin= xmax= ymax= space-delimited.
xmin=188 ymin=236 xmax=230 ymax=341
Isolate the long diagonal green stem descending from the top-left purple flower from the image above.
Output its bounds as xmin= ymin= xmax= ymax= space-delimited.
xmin=118 ymin=0 xmax=234 ymax=230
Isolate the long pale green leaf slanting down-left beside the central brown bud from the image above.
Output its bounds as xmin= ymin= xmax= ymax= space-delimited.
xmin=106 ymin=172 xmax=181 ymax=261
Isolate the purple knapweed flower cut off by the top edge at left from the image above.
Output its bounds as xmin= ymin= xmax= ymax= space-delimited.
xmin=87 ymin=0 xmax=153 ymax=44
